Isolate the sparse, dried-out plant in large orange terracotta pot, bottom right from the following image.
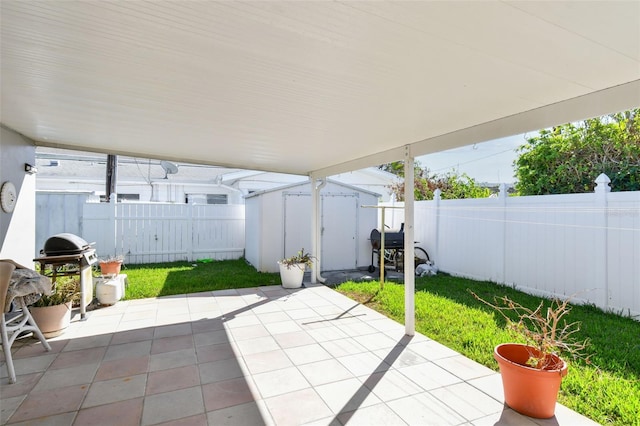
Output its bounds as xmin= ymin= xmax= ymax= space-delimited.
xmin=471 ymin=292 xmax=589 ymax=419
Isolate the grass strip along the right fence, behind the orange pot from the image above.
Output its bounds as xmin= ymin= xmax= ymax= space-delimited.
xmin=337 ymin=275 xmax=640 ymax=425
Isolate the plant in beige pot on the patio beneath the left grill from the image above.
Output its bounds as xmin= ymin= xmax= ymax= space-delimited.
xmin=29 ymin=277 xmax=80 ymax=338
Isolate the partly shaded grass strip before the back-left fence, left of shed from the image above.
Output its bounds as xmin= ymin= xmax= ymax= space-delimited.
xmin=122 ymin=259 xmax=280 ymax=300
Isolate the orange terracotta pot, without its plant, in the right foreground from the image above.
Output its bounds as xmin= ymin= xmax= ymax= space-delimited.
xmin=493 ymin=343 xmax=567 ymax=419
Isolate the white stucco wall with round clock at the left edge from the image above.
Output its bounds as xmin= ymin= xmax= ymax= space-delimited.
xmin=0 ymin=126 xmax=36 ymax=267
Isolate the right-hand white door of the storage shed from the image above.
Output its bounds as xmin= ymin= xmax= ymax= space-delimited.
xmin=321 ymin=194 xmax=358 ymax=271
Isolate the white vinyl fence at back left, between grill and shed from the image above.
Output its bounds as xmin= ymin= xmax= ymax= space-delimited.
xmin=36 ymin=194 xmax=245 ymax=263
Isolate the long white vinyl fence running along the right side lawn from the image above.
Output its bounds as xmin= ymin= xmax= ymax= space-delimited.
xmin=387 ymin=177 xmax=640 ymax=316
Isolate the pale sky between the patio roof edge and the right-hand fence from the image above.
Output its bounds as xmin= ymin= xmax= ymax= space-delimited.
xmin=416 ymin=135 xmax=526 ymax=183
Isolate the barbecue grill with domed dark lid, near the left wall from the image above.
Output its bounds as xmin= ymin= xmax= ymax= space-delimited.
xmin=33 ymin=233 xmax=98 ymax=320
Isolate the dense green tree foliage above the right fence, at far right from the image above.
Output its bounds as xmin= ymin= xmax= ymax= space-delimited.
xmin=514 ymin=109 xmax=640 ymax=195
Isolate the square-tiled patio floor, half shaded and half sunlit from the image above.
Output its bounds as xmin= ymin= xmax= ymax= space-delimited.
xmin=0 ymin=285 xmax=593 ymax=426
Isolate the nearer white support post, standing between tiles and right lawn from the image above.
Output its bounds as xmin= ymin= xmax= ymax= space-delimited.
xmin=404 ymin=145 xmax=416 ymax=336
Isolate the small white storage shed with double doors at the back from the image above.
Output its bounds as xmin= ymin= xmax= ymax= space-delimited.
xmin=245 ymin=180 xmax=379 ymax=272
